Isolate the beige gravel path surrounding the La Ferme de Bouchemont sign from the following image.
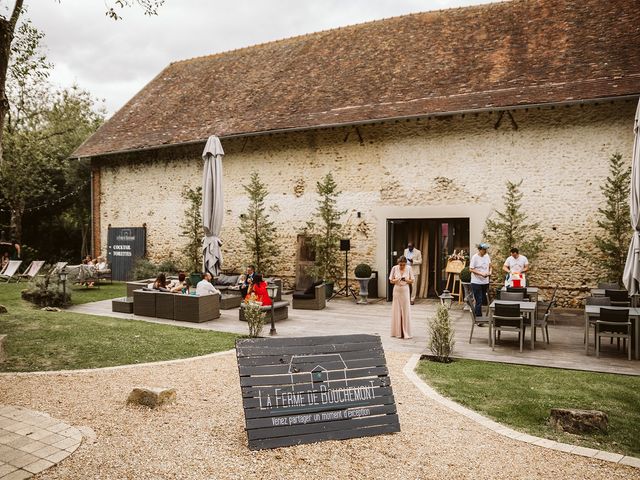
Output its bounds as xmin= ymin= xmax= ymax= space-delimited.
xmin=0 ymin=353 xmax=640 ymax=480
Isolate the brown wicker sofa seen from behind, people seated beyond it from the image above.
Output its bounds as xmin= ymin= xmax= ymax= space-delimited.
xmin=133 ymin=289 xmax=220 ymax=323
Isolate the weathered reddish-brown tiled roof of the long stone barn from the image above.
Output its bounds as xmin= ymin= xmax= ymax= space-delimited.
xmin=74 ymin=0 xmax=640 ymax=156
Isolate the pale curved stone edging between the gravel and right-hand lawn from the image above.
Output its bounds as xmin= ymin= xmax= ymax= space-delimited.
xmin=402 ymin=354 xmax=640 ymax=468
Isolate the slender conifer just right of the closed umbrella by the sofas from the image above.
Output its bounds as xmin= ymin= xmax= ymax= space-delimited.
xmin=240 ymin=172 xmax=280 ymax=274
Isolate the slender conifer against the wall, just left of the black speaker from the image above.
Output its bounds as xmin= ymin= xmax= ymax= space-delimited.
xmin=307 ymin=173 xmax=346 ymax=281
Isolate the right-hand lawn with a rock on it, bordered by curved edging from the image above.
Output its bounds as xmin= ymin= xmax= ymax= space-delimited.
xmin=417 ymin=360 xmax=640 ymax=456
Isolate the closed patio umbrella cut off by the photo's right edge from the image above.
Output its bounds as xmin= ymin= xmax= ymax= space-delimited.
xmin=622 ymin=100 xmax=640 ymax=295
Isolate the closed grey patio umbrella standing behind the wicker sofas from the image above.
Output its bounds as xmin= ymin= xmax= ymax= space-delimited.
xmin=202 ymin=135 xmax=224 ymax=277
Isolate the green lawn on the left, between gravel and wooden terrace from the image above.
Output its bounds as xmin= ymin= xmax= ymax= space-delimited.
xmin=0 ymin=283 xmax=238 ymax=372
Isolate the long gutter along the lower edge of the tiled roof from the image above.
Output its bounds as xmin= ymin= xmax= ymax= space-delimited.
xmin=75 ymin=92 xmax=640 ymax=160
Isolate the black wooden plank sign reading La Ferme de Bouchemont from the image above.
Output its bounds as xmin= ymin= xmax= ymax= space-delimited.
xmin=236 ymin=335 xmax=400 ymax=450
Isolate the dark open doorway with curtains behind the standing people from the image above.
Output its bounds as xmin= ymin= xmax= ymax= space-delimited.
xmin=387 ymin=218 xmax=469 ymax=301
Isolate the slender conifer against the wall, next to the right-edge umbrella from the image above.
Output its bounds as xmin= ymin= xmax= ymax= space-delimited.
xmin=581 ymin=153 xmax=632 ymax=285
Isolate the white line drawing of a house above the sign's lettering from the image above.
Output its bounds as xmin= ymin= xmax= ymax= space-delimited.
xmin=288 ymin=353 xmax=348 ymax=391
